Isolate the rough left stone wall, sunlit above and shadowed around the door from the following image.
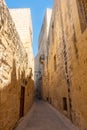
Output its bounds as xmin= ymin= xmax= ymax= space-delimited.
xmin=0 ymin=1 xmax=34 ymax=130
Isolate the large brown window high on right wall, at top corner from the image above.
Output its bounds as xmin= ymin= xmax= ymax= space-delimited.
xmin=77 ymin=0 xmax=87 ymax=32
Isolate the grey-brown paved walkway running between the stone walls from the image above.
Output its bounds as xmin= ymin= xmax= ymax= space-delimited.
xmin=15 ymin=101 xmax=78 ymax=130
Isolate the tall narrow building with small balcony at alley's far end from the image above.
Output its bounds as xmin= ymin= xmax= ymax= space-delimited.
xmin=35 ymin=8 xmax=52 ymax=96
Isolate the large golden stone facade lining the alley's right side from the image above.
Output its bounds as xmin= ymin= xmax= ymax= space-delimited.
xmin=38 ymin=0 xmax=87 ymax=130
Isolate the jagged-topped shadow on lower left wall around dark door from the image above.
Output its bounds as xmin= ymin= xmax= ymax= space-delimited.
xmin=0 ymin=60 xmax=34 ymax=130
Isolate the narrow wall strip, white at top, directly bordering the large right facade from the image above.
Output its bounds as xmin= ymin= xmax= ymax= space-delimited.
xmin=41 ymin=9 xmax=52 ymax=100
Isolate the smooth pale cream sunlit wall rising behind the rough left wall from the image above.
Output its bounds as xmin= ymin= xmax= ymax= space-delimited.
xmin=9 ymin=8 xmax=34 ymax=79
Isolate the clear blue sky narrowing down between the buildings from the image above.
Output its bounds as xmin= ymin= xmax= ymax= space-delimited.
xmin=6 ymin=0 xmax=53 ymax=56
